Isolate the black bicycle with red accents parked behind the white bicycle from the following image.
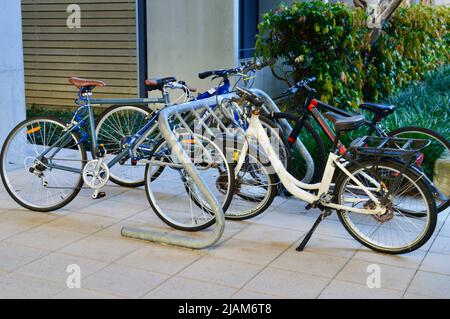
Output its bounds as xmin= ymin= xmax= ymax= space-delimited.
xmin=266 ymin=78 xmax=450 ymax=212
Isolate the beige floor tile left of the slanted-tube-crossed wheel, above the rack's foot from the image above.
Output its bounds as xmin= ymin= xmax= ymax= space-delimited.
xmin=80 ymin=199 xmax=148 ymax=219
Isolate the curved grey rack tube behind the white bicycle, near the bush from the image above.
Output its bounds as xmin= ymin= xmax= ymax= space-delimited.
xmin=251 ymin=89 xmax=315 ymax=183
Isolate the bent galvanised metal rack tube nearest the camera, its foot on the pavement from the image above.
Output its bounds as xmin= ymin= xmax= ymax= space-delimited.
xmin=122 ymin=94 xmax=235 ymax=249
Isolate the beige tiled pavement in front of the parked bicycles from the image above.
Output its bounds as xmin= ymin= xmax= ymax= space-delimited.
xmin=0 ymin=186 xmax=450 ymax=299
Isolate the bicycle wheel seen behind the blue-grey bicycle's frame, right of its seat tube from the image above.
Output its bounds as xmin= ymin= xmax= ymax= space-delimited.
xmin=96 ymin=105 xmax=157 ymax=187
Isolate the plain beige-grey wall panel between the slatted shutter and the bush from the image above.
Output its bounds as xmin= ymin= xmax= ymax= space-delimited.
xmin=147 ymin=0 xmax=238 ymax=95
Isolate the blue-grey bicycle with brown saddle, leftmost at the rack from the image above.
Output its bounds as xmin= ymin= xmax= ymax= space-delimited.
xmin=0 ymin=78 xmax=234 ymax=227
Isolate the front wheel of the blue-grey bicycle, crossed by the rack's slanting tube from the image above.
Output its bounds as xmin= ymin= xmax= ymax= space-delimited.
xmin=145 ymin=133 xmax=234 ymax=231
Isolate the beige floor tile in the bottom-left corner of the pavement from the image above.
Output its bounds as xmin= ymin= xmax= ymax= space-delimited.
xmin=0 ymin=274 xmax=63 ymax=299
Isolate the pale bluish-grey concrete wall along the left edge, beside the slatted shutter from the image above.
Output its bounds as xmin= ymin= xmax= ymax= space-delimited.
xmin=0 ymin=0 xmax=25 ymax=146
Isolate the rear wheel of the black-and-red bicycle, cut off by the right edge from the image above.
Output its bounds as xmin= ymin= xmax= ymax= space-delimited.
xmin=389 ymin=126 xmax=450 ymax=212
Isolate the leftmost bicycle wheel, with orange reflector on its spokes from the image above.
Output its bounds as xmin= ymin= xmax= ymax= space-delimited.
xmin=0 ymin=117 xmax=87 ymax=212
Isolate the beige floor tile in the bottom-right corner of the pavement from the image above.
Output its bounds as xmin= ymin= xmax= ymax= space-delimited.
xmin=407 ymin=271 xmax=450 ymax=299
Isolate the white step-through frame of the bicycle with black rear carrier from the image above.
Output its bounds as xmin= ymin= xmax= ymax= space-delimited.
xmin=236 ymin=112 xmax=386 ymax=215
